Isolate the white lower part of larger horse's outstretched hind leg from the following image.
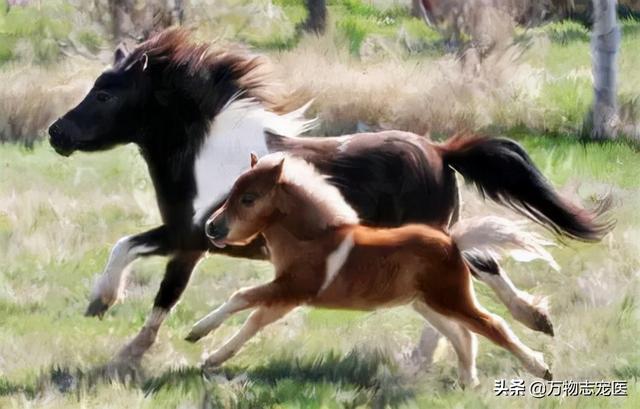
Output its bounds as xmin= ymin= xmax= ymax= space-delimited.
xmin=473 ymin=268 xmax=553 ymax=335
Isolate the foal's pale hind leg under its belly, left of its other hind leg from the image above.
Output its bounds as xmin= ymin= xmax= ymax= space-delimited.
xmin=413 ymin=301 xmax=479 ymax=387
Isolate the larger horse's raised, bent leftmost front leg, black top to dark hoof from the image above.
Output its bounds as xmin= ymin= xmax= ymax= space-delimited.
xmin=85 ymin=226 xmax=172 ymax=317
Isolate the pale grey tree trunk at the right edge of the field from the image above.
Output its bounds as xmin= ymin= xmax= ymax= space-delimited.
xmin=591 ymin=0 xmax=620 ymax=139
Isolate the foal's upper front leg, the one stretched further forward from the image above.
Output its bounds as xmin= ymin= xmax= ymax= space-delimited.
xmin=185 ymin=281 xmax=281 ymax=342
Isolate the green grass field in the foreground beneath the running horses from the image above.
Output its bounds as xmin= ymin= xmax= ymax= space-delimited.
xmin=0 ymin=136 xmax=640 ymax=408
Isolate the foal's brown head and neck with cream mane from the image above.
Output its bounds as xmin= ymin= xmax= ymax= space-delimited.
xmin=205 ymin=153 xmax=358 ymax=246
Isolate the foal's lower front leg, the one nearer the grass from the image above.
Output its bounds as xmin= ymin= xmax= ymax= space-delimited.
xmin=204 ymin=305 xmax=294 ymax=368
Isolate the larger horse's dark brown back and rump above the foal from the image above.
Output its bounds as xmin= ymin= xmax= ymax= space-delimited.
xmin=277 ymin=131 xmax=458 ymax=228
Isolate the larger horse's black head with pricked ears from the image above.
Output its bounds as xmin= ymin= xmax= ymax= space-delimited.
xmin=49 ymin=48 xmax=150 ymax=156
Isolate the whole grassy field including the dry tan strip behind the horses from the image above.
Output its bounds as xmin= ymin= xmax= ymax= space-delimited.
xmin=0 ymin=0 xmax=640 ymax=409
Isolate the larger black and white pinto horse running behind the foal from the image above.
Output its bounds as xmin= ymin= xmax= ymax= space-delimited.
xmin=49 ymin=29 xmax=612 ymax=362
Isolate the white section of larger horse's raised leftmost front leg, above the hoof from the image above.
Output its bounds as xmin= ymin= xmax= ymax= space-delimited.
xmin=91 ymin=236 xmax=154 ymax=306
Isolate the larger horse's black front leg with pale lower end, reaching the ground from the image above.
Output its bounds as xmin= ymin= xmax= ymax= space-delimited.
xmin=116 ymin=250 xmax=204 ymax=363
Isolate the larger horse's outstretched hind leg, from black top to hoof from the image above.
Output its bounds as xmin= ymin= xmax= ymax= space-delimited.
xmin=464 ymin=252 xmax=553 ymax=336
